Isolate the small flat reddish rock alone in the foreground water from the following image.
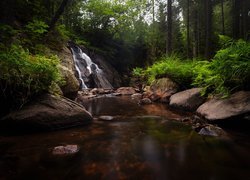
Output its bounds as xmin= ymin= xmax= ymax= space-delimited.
xmin=52 ymin=145 xmax=80 ymax=155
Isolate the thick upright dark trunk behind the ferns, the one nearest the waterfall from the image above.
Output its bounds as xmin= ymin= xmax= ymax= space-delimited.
xmin=166 ymin=0 xmax=172 ymax=55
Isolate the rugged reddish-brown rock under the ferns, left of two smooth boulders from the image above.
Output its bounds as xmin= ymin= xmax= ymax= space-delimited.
xmin=144 ymin=78 xmax=178 ymax=103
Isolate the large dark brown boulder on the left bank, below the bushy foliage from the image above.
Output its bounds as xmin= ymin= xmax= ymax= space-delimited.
xmin=0 ymin=94 xmax=92 ymax=132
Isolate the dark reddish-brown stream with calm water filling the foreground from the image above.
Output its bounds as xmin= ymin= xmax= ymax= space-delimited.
xmin=0 ymin=96 xmax=250 ymax=180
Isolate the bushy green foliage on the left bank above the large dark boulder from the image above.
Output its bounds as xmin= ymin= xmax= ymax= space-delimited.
xmin=0 ymin=45 xmax=61 ymax=105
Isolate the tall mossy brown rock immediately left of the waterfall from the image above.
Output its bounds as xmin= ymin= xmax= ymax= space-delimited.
xmin=56 ymin=46 xmax=80 ymax=99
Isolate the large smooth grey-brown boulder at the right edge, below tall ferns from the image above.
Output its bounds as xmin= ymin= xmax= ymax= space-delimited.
xmin=197 ymin=91 xmax=250 ymax=121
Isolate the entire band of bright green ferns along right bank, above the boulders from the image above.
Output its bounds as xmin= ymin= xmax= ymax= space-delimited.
xmin=133 ymin=36 xmax=250 ymax=97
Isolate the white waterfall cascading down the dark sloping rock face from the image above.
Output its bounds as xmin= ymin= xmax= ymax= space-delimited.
xmin=71 ymin=45 xmax=113 ymax=89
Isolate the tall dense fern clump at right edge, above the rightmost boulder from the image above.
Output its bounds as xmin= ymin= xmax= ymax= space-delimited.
xmin=194 ymin=38 xmax=250 ymax=96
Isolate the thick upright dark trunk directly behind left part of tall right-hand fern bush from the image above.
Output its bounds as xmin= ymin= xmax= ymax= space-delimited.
xmin=205 ymin=0 xmax=212 ymax=59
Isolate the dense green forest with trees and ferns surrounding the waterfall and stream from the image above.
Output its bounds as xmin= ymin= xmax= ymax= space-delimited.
xmin=0 ymin=0 xmax=250 ymax=107
